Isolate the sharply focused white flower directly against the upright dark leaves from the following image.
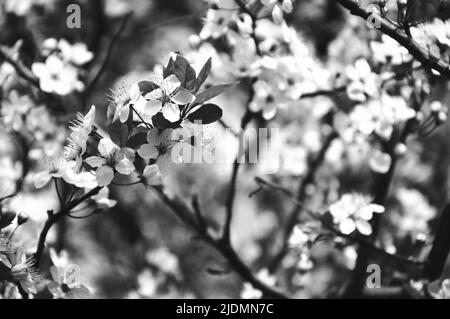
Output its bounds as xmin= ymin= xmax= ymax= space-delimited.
xmin=145 ymin=66 xmax=195 ymax=122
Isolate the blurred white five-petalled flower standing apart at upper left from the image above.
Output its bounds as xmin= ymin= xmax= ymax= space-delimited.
xmin=31 ymin=55 xmax=84 ymax=95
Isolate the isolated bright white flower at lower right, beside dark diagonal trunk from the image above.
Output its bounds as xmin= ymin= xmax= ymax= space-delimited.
xmin=329 ymin=194 xmax=384 ymax=235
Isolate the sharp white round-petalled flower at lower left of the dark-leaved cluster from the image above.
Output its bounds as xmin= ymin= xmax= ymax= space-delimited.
xmin=85 ymin=138 xmax=135 ymax=186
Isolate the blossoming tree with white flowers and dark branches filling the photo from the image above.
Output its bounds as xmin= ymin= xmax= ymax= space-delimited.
xmin=0 ymin=0 xmax=450 ymax=298
